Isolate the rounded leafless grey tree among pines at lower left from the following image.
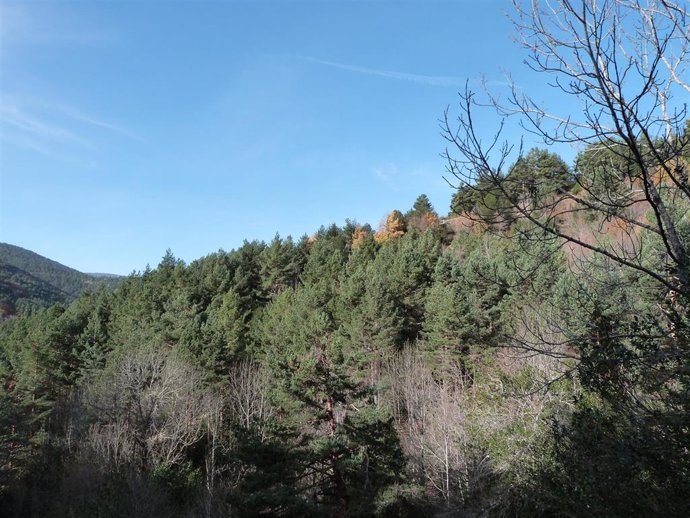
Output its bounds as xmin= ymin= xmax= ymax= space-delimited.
xmin=86 ymin=349 xmax=215 ymax=472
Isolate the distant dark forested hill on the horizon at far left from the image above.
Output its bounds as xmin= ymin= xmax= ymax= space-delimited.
xmin=0 ymin=243 xmax=121 ymax=318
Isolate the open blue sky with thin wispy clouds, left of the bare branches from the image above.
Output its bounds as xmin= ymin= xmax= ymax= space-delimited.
xmin=0 ymin=0 xmax=568 ymax=274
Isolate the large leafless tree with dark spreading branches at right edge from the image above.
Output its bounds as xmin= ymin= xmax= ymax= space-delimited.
xmin=441 ymin=0 xmax=690 ymax=408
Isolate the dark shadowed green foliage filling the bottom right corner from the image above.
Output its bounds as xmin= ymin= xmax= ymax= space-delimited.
xmin=513 ymin=398 xmax=690 ymax=517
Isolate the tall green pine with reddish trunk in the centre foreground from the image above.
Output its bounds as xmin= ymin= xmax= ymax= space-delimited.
xmin=251 ymin=287 xmax=402 ymax=516
